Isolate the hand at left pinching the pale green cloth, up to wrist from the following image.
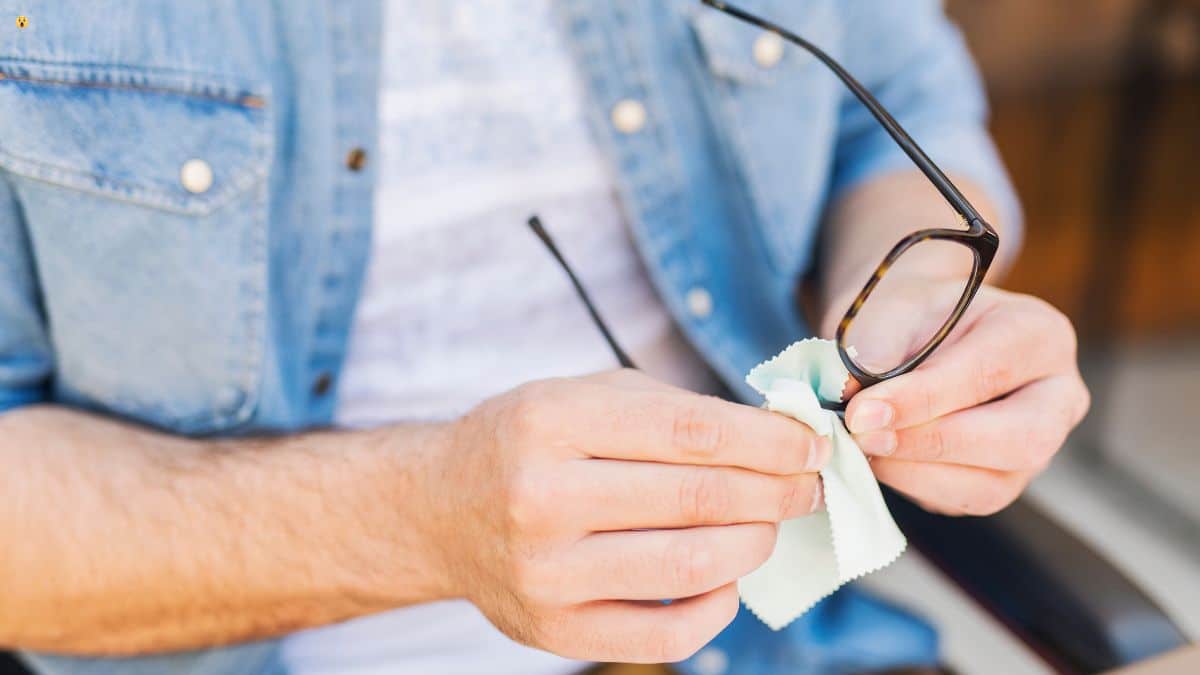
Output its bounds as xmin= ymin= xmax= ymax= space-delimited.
xmin=426 ymin=370 xmax=830 ymax=662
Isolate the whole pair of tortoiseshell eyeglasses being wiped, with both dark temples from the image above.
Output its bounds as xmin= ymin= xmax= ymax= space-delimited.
xmin=529 ymin=0 xmax=1000 ymax=412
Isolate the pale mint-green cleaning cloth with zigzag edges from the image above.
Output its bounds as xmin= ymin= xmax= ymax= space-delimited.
xmin=738 ymin=339 xmax=907 ymax=631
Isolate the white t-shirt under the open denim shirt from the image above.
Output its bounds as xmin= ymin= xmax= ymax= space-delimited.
xmin=276 ymin=0 xmax=713 ymax=675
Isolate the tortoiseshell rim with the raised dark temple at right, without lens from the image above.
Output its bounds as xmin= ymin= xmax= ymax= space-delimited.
xmin=701 ymin=0 xmax=1000 ymax=403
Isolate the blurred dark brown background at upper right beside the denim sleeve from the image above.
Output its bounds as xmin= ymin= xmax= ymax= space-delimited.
xmin=948 ymin=0 xmax=1200 ymax=339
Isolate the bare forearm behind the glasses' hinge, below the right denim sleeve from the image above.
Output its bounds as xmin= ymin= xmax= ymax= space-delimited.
xmin=820 ymin=169 xmax=1014 ymax=324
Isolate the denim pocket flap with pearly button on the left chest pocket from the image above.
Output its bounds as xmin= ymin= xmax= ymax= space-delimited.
xmin=0 ymin=59 xmax=271 ymax=215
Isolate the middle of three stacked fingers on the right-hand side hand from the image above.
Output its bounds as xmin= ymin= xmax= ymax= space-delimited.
xmin=854 ymin=375 xmax=1087 ymax=471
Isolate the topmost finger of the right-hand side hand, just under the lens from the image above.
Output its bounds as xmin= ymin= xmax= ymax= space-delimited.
xmin=846 ymin=298 xmax=1075 ymax=434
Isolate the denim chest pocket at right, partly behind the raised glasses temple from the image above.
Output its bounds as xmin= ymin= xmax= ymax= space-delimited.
xmin=692 ymin=0 xmax=842 ymax=275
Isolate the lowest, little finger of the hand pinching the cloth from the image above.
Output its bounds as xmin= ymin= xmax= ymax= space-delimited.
xmin=541 ymin=584 xmax=738 ymax=663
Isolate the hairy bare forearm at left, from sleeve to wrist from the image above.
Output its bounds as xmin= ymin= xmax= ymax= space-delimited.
xmin=0 ymin=407 xmax=443 ymax=655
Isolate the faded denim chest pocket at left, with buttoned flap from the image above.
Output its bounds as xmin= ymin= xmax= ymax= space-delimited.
xmin=0 ymin=59 xmax=272 ymax=434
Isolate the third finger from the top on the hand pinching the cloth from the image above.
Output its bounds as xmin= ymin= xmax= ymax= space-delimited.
xmin=559 ymin=522 xmax=776 ymax=603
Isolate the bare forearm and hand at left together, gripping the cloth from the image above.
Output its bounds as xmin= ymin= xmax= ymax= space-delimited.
xmin=0 ymin=372 xmax=829 ymax=662
